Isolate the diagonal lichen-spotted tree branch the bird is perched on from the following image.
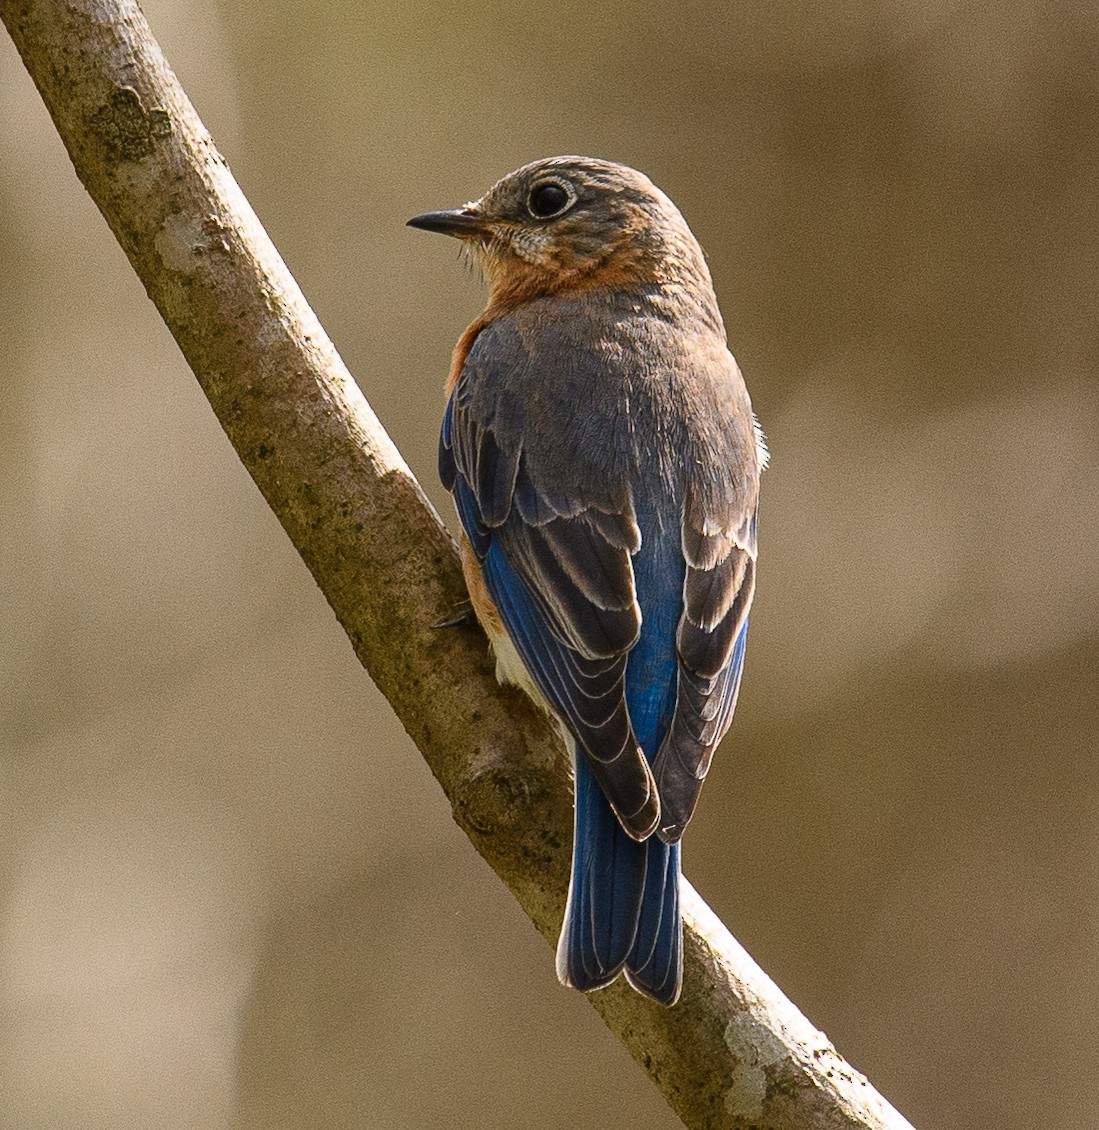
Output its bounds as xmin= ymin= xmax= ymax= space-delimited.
xmin=0 ymin=0 xmax=910 ymax=1130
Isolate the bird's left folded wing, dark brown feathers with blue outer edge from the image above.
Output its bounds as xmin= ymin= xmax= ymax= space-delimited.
xmin=439 ymin=381 xmax=658 ymax=840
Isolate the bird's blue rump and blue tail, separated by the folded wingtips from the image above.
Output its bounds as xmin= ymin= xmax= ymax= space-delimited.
xmin=557 ymin=513 xmax=684 ymax=1005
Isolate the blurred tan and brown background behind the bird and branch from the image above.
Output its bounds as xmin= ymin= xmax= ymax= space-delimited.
xmin=0 ymin=0 xmax=1099 ymax=1130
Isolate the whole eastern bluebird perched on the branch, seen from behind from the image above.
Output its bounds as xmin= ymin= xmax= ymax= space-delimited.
xmin=409 ymin=157 xmax=767 ymax=1005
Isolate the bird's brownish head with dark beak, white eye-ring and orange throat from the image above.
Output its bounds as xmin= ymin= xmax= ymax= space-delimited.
xmin=409 ymin=157 xmax=710 ymax=304
